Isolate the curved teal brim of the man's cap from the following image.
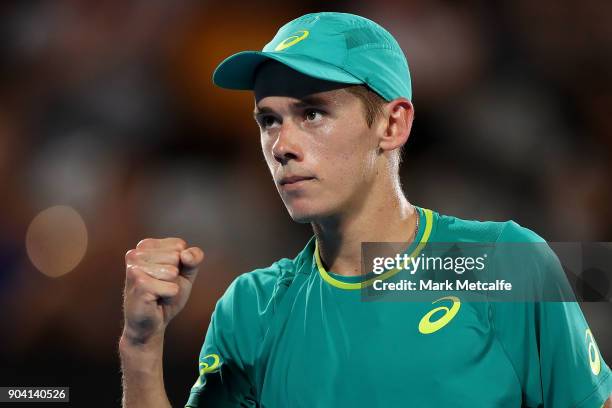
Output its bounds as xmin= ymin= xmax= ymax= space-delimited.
xmin=213 ymin=51 xmax=363 ymax=90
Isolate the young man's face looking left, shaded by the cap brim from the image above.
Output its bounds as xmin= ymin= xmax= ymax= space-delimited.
xmin=254 ymin=62 xmax=379 ymax=222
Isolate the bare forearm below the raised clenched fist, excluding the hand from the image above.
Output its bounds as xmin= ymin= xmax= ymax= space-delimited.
xmin=119 ymin=334 xmax=171 ymax=408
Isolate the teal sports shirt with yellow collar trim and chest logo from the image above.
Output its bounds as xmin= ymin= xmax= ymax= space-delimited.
xmin=186 ymin=209 xmax=612 ymax=408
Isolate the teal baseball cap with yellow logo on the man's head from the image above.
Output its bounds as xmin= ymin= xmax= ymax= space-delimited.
xmin=213 ymin=12 xmax=412 ymax=101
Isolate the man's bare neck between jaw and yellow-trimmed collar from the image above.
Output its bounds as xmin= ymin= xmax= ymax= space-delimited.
xmin=312 ymin=174 xmax=418 ymax=276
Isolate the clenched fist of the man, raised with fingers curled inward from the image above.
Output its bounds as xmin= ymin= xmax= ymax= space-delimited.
xmin=123 ymin=238 xmax=204 ymax=344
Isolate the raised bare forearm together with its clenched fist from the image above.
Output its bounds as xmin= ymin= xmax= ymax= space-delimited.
xmin=119 ymin=238 xmax=204 ymax=408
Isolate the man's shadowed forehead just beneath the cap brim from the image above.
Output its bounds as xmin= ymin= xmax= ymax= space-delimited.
xmin=253 ymin=60 xmax=352 ymax=102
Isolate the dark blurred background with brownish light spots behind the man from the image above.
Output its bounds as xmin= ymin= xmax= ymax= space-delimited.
xmin=0 ymin=0 xmax=612 ymax=407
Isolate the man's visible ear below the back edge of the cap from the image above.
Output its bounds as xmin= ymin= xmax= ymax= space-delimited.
xmin=378 ymin=98 xmax=414 ymax=152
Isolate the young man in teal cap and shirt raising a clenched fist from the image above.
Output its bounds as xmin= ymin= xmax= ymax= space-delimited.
xmin=120 ymin=13 xmax=612 ymax=408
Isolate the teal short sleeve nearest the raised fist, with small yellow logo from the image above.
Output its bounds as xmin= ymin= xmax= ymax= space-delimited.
xmin=186 ymin=259 xmax=284 ymax=408
